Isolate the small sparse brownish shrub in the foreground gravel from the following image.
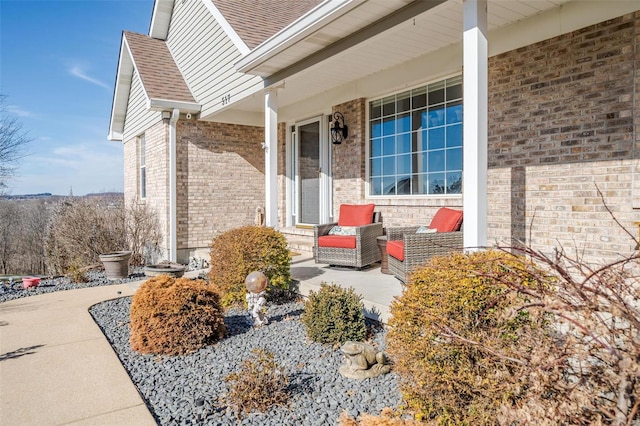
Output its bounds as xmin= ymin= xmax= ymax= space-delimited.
xmin=224 ymin=349 xmax=289 ymax=418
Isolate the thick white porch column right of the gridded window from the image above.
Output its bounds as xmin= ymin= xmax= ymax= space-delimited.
xmin=462 ymin=0 xmax=488 ymax=250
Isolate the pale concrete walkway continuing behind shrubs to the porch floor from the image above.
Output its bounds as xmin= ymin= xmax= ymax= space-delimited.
xmin=0 ymin=258 xmax=401 ymax=426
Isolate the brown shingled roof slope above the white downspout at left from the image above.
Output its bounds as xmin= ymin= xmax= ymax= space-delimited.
xmin=124 ymin=31 xmax=195 ymax=102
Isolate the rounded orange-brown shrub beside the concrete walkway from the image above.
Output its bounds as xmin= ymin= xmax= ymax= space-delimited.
xmin=130 ymin=275 xmax=226 ymax=355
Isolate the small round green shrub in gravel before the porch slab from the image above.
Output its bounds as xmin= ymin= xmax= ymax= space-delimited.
xmin=301 ymin=283 xmax=367 ymax=344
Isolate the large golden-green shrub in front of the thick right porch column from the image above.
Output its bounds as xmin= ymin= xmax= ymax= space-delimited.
xmin=387 ymin=251 xmax=552 ymax=425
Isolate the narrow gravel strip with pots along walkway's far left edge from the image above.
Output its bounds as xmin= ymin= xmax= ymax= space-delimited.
xmin=0 ymin=267 xmax=146 ymax=303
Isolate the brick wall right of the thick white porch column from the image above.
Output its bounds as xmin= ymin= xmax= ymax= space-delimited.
xmin=488 ymin=13 xmax=640 ymax=262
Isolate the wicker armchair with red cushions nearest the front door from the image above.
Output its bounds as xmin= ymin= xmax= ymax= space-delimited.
xmin=314 ymin=204 xmax=383 ymax=269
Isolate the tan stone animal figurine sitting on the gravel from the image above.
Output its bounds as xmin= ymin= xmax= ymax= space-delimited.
xmin=339 ymin=342 xmax=391 ymax=380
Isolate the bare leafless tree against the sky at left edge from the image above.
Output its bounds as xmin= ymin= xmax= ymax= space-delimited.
xmin=0 ymin=94 xmax=31 ymax=193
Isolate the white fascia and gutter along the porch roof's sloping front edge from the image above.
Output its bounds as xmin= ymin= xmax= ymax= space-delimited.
xmin=235 ymin=0 xmax=364 ymax=74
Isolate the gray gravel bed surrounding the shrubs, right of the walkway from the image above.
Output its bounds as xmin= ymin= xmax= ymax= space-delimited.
xmin=90 ymin=297 xmax=401 ymax=426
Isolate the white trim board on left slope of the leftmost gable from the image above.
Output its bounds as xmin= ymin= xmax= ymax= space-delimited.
xmin=107 ymin=34 xmax=134 ymax=141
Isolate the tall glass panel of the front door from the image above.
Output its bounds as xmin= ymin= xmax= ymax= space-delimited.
xmin=298 ymin=121 xmax=320 ymax=224
